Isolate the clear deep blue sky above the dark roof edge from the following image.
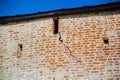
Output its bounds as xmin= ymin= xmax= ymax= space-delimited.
xmin=0 ymin=0 xmax=120 ymax=16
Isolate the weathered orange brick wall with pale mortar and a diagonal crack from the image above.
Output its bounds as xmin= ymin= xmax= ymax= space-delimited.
xmin=0 ymin=11 xmax=120 ymax=80
